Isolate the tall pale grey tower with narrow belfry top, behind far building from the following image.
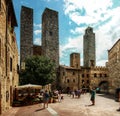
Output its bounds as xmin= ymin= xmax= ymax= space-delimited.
xmin=83 ymin=27 xmax=96 ymax=67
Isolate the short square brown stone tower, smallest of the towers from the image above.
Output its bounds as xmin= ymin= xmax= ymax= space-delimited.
xmin=70 ymin=53 xmax=80 ymax=68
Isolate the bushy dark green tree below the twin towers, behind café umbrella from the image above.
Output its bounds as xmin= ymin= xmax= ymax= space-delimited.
xmin=20 ymin=56 xmax=56 ymax=86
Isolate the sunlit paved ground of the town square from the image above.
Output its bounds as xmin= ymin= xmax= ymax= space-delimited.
xmin=2 ymin=93 xmax=120 ymax=116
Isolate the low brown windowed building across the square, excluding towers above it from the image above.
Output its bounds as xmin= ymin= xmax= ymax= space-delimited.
xmin=58 ymin=53 xmax=109 ymax=92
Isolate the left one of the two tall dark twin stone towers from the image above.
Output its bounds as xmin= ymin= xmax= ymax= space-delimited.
xmin=20 ymin=6 xmax=33 ymax=68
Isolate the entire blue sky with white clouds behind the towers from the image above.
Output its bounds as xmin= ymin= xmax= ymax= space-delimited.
xmin=13 ymin=0 xmax=120 ymax=66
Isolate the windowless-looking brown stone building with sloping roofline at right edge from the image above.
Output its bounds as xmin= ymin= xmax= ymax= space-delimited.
xmin=107 ymin=39 xmax=120 ymax=93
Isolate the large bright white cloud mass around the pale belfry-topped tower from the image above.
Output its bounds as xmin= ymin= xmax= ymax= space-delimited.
xmin=61 ymin=0 xmax=120 ymax=66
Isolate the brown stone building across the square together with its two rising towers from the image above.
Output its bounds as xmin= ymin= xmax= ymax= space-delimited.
xmin=58 ymin=27 xmax=109 ymax=91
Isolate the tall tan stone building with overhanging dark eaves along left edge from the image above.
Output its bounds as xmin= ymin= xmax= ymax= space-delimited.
xmin=0 ymin=0 xmax=18 ymax=114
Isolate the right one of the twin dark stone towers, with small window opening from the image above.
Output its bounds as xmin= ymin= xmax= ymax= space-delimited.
xmin=42 ymin=8 xmax=59 ymax=68
